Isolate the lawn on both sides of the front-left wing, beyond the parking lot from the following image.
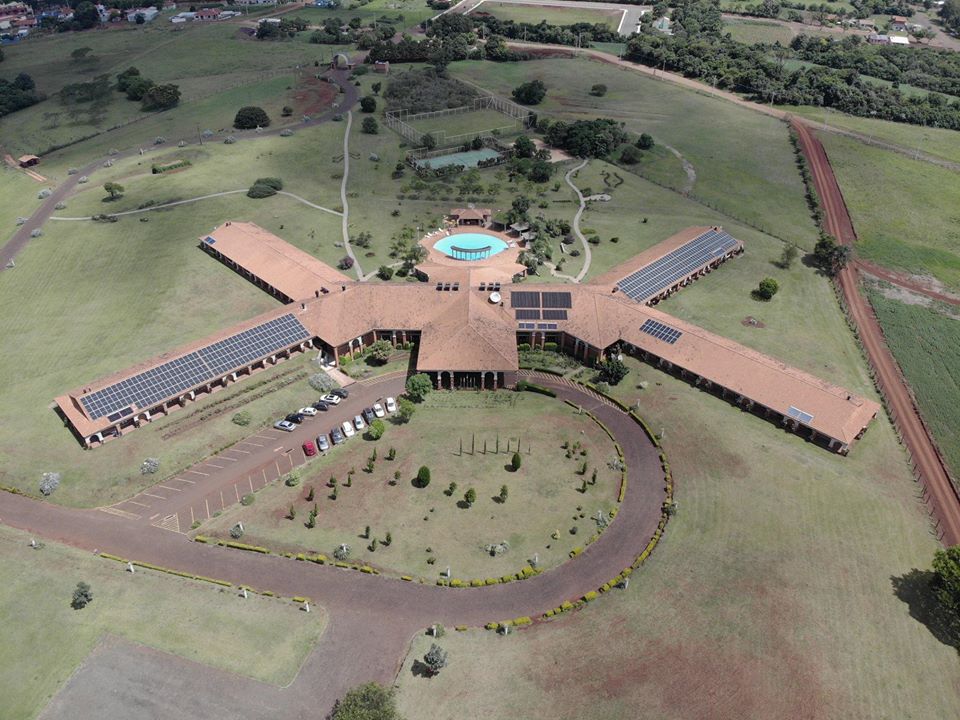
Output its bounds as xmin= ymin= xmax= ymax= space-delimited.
xmin=0 ymin=195 xmax=342 ymax=505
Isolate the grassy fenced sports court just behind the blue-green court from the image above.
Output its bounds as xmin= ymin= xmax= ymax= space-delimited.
xmin=384 ymin=95 xmax=530 ymax=148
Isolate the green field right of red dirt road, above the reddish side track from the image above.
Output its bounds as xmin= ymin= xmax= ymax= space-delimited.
xmin=819 ymin=133 xmax=960 ymax=290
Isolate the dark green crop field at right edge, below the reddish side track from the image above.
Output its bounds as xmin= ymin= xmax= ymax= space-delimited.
xmin=870 ymin=290 xmax=960 ymax=475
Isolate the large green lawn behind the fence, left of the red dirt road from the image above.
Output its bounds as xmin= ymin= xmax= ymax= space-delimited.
xmin=449 ymin=59 xmax=816 ymax=248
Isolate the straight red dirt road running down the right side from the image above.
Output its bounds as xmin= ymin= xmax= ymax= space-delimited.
xmin=793 ymin=120 xmax=960 ymax=545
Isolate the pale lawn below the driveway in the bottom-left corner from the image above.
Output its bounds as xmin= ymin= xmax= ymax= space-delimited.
xmin=0 ymin=527 xmax=326 ymax=720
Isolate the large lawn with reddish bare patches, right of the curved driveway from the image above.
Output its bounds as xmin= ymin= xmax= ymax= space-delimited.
xmin=399 ymin=358 xmax=960 ymax=720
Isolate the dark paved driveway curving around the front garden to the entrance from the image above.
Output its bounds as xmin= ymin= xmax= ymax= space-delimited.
xmin=0 ymin=376 xmax=663 ymax=717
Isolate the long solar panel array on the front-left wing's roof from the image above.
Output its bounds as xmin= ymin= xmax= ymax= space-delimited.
xmin=80 ymin=315 xmax=310 ymax=422
